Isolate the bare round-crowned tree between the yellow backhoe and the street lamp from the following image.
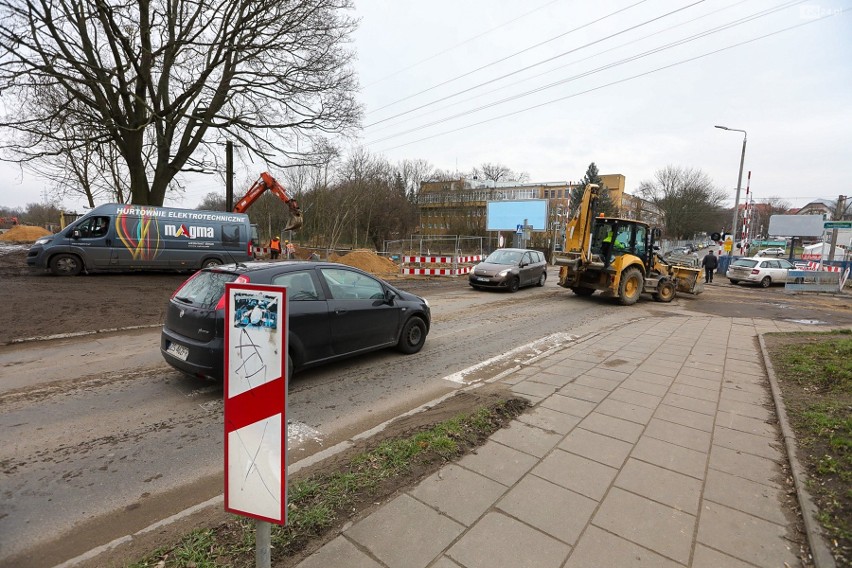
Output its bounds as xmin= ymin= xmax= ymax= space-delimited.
xmin=638 ymin=166 xmax=725 ymax=239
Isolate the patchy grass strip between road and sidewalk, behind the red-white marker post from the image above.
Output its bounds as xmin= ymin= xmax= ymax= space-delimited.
xmin=129 ymin=399 xmax=528 ymax=568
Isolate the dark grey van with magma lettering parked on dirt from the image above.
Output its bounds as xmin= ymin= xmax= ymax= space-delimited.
xmin=27 ymin=203 xmax=257 ymax=276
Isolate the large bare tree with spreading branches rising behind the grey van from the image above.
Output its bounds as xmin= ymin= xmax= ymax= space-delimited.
xmin=0 ymin=0 xmax=360 ymax=205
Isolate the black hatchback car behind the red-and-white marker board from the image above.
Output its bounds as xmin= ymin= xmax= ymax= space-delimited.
xmin=160 ymin=262 xmax=431 ymax=380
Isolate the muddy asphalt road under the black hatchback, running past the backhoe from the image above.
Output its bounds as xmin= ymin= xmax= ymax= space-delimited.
xmin=0 ymin=268 xmax=852 ymax=567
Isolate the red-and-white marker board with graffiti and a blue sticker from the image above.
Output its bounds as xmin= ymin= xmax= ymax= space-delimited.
xmin=225 ymin=283 xmax=288 ymax=524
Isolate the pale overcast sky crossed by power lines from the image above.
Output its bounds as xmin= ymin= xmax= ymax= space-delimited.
xmin=0 ymin=0 xmax=852 ymax=212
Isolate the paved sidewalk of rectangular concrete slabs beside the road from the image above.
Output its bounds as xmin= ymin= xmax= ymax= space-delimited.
xmin=299 ymin=316 xmax=814 ymax=568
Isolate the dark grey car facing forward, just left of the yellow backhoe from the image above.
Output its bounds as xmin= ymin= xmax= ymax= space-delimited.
xmin=468 ymin=248 xmax=547 ymax=292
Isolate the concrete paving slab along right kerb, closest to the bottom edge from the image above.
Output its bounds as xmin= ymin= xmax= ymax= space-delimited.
xmin=698 ymin=501 xmax=798 ymax=568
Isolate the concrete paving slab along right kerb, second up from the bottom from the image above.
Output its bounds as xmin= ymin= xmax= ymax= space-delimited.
xmin=704 ymin=469 xmax=787 ymax=525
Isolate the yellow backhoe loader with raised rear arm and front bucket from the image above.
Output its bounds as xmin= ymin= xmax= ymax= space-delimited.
xmin=554 ymin=184 xmax=703 ymax=305
